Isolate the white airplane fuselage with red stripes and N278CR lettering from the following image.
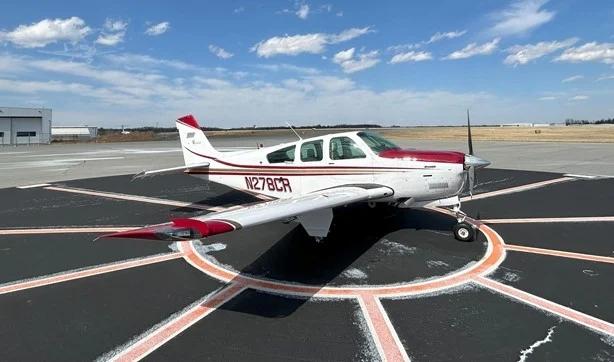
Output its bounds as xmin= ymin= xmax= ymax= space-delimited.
xmin=182 ymin=132 xmax=466 ymax=202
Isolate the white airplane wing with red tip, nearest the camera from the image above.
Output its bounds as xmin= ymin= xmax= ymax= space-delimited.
xmin=102 ymin=185 xmax=393 ymax=241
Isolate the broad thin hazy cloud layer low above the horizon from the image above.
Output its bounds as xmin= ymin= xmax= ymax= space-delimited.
xmin=0 ymin=48 xmax=614 ymax=127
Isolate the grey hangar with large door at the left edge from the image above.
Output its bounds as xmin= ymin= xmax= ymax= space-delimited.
xmin=0 ymin=107 xmax=51 ymax=145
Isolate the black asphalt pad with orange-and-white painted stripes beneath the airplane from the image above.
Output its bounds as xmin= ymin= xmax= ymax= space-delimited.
xmin=0 ymin=169 xmax=614 ymax=361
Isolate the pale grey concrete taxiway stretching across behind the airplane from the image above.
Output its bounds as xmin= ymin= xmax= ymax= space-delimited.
xmin=0 ymin=133 xmax=614 ymax=188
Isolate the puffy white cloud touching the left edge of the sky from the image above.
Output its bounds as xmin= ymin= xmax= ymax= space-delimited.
xmin=0 ymin=16 xmax=91 ymax=48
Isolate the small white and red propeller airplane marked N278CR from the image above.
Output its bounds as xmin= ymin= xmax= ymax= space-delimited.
xmin=103 ymin=112 xmax=490 ymax=241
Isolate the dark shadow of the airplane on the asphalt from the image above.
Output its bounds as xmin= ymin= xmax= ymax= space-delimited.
xmin=205 ymin=205 xmax=468 ymax=318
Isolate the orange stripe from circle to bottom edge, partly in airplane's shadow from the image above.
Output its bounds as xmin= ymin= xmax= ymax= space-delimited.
xmin=110 ymin=283 xmax=246 ymax=361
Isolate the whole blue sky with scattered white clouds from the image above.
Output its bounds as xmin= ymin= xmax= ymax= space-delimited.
xmin=0 ymin=0 xmax=614 ymax=127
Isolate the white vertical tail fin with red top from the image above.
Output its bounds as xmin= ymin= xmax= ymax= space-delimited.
xmin=176 ymin=114 xmax=220 ymax=166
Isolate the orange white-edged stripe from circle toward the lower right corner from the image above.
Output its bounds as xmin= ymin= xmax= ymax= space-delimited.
xmin=475 ymin=276 xmax=614 ymax=335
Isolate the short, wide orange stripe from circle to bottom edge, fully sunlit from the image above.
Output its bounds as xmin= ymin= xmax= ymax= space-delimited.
xmin=358 ymin=294 xmax=409 ymax=361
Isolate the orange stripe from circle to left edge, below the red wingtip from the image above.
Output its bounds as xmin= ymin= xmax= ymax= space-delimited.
xmin=0 ymin=252 xmax=182 ymax=294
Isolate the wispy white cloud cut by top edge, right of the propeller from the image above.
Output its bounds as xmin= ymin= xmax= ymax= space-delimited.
xmin=489 ymin=0 xmax=556 ymax=36
